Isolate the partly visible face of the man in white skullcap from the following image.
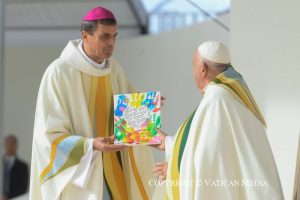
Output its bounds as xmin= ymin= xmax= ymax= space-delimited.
xmin=193 ymin=50 xmax=205 ymax=92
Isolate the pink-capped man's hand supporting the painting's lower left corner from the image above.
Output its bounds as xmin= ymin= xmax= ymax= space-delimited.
xmin=93 ymin=136 xmax=127 ymax=152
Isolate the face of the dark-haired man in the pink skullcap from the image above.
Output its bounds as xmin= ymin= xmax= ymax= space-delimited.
xmin=82 ymin=24 xmax=118 ymax=63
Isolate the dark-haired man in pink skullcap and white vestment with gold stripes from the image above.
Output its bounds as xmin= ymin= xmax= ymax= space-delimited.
xmin=30 ymin=7 xmax=153 ymax=200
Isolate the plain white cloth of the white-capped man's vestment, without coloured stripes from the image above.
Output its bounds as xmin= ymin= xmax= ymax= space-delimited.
xmin=167 ymin=85 xmax=283 ymax=200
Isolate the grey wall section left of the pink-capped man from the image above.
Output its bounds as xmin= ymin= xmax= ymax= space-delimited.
xmin=3 ymin=48 xmax=60 ymax=163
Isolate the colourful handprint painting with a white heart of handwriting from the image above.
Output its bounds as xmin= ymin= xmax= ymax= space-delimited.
xmin=114 ymin=92 xmax=161 ymax=145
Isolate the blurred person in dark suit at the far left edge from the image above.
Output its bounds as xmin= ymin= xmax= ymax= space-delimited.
xmin=2 ymin=135 xmax=28 ymax=200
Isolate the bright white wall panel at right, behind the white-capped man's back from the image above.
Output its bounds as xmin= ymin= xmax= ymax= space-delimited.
xmin=231 ymin=0 xmax=300 ymax=199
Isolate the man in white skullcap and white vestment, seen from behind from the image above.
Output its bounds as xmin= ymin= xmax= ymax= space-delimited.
xmin=153 ymin=41 xmax=283 ymax=200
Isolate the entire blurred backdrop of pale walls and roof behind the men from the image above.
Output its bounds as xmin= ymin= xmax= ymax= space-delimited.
xmin=0 ymin=0 xmax=300 ymax=199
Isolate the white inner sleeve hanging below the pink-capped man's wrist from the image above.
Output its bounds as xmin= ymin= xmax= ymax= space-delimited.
xmin=70 ymin=139 xmax=99 ymax=189
